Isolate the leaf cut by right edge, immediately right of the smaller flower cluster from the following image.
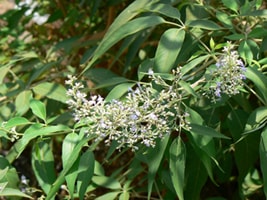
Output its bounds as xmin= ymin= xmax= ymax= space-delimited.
xmin=245 ymin=67 xmax=267 ymax=105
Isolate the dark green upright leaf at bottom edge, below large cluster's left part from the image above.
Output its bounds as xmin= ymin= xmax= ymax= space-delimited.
xmin=77 ymin=150 xmax=95 ymax=199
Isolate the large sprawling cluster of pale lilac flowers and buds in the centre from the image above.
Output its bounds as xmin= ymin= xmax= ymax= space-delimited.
xmin=66 ymin=70 xmax=190 ymax=150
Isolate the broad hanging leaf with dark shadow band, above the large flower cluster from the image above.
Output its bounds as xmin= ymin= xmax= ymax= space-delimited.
xmin=154 ymin=28 xmax=185 ymax=73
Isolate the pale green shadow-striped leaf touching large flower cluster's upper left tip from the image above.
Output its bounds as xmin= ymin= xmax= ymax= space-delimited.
xmin=32 ymin=82 xmax=68 ymax=103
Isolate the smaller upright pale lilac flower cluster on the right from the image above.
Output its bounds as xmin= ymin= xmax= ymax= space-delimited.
xmin=204 ymin=42 xmax=246 ymax=101
